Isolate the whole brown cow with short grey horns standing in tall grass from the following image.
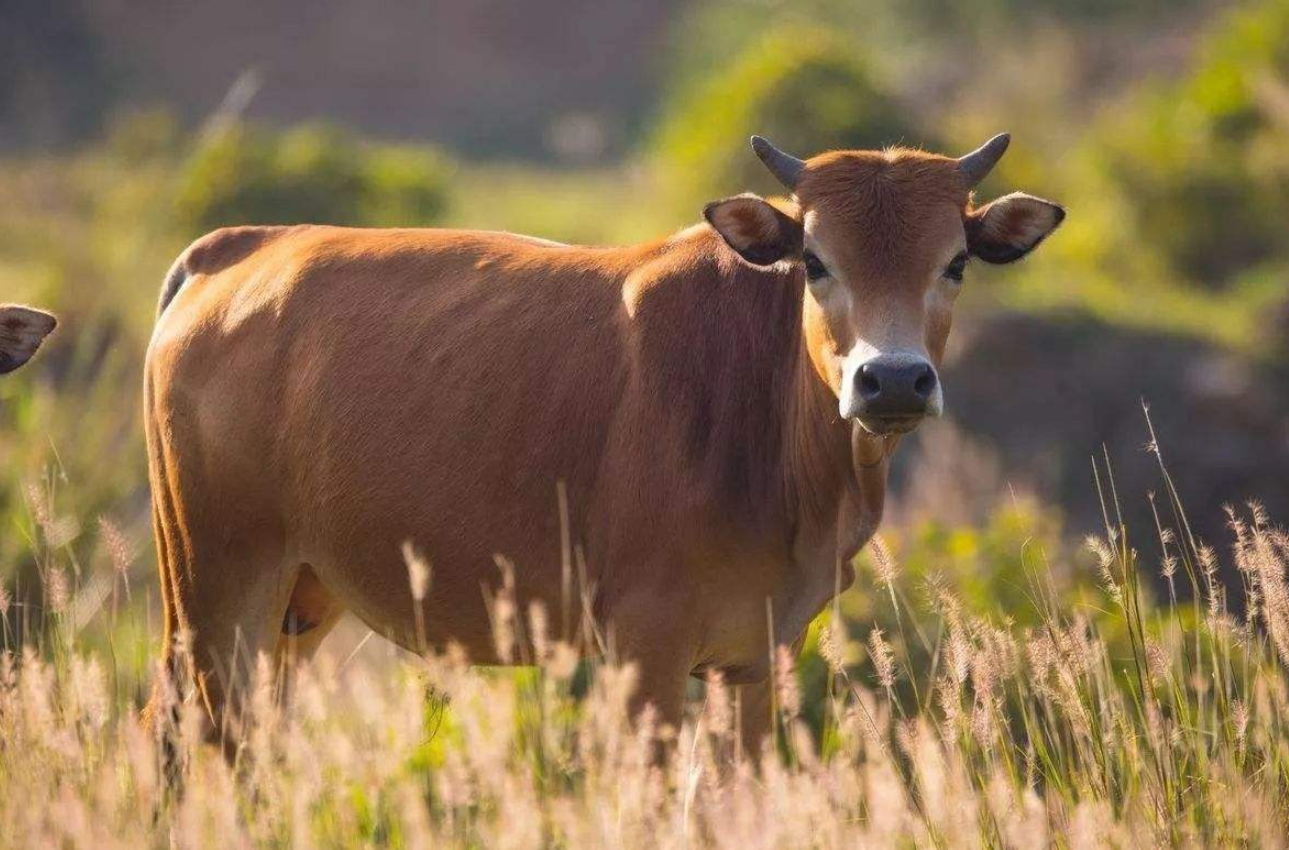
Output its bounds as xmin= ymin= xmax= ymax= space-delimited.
xmin=146 ymin=135 xmax=1063 ymax=753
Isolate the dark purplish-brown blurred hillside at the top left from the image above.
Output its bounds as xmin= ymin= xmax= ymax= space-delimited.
xmin=0 ymin=0 xmax=679 ymax=155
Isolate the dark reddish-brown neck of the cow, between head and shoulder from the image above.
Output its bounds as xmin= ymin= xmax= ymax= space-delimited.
xmin=624 ymin=227 xmax=887 ymax=571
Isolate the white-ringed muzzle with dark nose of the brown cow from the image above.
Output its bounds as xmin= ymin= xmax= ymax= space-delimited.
xmin=840 ymin=355 xmax=942 ymax=435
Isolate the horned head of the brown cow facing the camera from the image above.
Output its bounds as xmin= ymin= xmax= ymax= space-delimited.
xmin=704 ymin=134 xmax=1065 ymax=435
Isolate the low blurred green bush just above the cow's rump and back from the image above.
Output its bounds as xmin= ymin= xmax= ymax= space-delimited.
xmin=175 ymin=124 xmax=450 ymax=232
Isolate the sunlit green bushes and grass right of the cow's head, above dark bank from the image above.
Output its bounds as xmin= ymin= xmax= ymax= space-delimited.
xmin=977 ymin=0 xmax=1289 ymax=359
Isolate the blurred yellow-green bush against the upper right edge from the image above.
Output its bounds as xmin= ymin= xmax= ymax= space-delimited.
xmin=1089 ymin=3 xmax=1289 ymax=288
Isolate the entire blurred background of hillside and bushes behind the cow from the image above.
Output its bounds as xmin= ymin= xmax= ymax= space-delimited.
xmin=0 ymin=0 xmax=1289 ymax=619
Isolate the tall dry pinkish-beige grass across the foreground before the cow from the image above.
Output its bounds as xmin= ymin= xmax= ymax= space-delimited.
xmin=0 ymin=435 xmax=1289 ymax=850
